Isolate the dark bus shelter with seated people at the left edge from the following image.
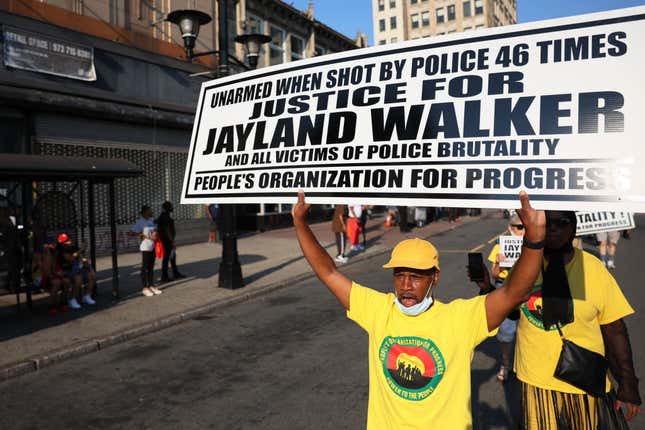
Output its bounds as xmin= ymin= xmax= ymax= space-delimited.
xmin=0 ymin=154 xmax=143 ymax=308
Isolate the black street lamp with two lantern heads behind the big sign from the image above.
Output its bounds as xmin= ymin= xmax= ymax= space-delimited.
xmin=166 ymin=4 xmax=271 ymax=289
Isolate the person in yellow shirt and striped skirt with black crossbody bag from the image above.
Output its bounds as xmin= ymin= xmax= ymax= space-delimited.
xmin=506 ymin=211 xmax=641 ymax=430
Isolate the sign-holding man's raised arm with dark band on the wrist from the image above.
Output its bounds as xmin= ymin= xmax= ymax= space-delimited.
xmin=486 ymin=191 xmax=546 ymax=330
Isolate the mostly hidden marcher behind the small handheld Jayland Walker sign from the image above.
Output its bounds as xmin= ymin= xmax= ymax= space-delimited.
xmin=468 ymin=214 xmax=524 ymax=382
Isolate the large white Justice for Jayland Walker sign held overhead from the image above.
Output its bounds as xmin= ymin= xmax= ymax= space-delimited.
xmin=182 ymin=7 xmax=645 ymax=211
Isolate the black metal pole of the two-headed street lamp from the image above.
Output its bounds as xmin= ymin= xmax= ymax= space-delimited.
xmin=217 ymin=0 xmax=244 ymax=289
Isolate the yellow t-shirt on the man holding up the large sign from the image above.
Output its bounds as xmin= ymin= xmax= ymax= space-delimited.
xmin=347 ymin=283 xmax=489 ymax=430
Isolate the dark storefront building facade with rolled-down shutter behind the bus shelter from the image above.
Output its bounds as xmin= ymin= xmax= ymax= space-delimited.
xmin=0 ymin=0 xmax=359 ymax=252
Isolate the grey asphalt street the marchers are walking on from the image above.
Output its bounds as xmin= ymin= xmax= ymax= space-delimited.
xmin=0 ymin=219 xmax=645 ymax=429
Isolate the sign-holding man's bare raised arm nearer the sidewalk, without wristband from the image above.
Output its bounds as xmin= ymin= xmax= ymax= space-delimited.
xmin=291 ymin=191 xmax=352 ymax=310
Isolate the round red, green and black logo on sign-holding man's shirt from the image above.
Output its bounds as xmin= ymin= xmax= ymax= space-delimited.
xmin=379 ymin=336 xmax=446 ymax=401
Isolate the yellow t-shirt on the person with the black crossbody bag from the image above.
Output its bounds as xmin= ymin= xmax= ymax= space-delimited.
xmin=515 ymin=249 xmax=634 ymax=394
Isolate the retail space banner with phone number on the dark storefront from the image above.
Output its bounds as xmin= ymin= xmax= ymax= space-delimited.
xmin=3 ymin=27 xmax=96 ymax=81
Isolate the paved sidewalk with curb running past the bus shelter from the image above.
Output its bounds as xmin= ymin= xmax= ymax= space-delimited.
xmin=0 ymin=211 xmax=491 ymax=381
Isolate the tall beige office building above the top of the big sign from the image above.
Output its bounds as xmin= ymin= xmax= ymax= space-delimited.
xmin=372 ymin=0 xmax=517 ymax=45
